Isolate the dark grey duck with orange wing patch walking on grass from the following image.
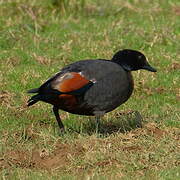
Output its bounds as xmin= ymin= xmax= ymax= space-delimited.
xmin=28 ymin=49 xmax=156 ymax=130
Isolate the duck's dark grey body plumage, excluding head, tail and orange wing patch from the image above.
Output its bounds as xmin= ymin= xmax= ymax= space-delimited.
xmin=41 ymin=60 xmax=133 ymax=115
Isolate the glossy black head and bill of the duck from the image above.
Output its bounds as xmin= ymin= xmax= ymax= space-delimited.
xmin=112 ymin=49 xmax=156 ymax=72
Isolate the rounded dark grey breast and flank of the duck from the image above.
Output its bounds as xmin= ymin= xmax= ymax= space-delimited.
xmin=83 ymin=65 xmax=133 ymax=112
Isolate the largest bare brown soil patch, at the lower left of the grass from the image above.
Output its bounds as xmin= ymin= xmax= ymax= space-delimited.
xmin=0 ymin=143 xmax=83 ymax=170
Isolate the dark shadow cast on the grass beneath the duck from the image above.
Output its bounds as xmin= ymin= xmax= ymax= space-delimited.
xmin=67 ymin=111 xmax=143 ymax=136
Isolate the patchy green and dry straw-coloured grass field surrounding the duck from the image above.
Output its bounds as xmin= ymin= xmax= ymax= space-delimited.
xmin=0 ymin=0 xmax=180 ymax=180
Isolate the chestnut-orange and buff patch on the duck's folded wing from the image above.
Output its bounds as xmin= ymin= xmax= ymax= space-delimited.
xmin=51 ymin=72 xmax=93 ymax=95
